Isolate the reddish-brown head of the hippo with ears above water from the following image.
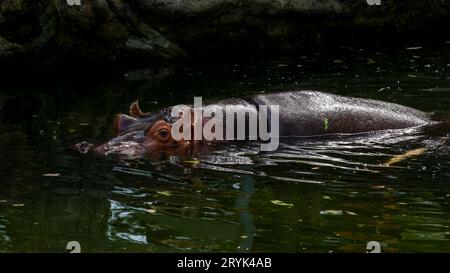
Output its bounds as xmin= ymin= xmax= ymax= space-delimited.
xmin=95 ymin=102 xmax=193 ymax=160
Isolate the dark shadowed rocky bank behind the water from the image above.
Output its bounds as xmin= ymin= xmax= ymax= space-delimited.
xmin=0 ymin=0 xmax=450 ymax=63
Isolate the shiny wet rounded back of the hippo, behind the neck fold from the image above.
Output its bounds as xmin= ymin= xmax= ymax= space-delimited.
xmin=251 ymin=91 xmax=430 ymax=136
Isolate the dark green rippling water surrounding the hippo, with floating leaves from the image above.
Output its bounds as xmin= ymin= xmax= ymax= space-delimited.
xmin=0 ymin=43 xmax=450 ymax=252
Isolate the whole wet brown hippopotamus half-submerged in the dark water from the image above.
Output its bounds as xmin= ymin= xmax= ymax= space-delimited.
xmin=85 ymin=91 xmax=435 ymax=158
